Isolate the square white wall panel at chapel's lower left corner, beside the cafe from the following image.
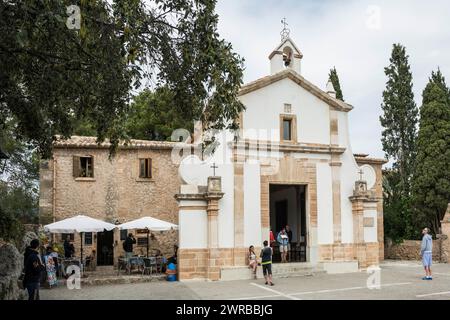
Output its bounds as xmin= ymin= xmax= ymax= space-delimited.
xmin=178 ymin=210 xmax=208 ymax=249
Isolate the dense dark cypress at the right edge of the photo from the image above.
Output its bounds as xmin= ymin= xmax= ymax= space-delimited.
xmin=413 ymin=70 xmax=450 ymax=233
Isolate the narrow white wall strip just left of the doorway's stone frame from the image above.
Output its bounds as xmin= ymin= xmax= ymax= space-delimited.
xmin=244 ymin=163 xmax=262 ymax=247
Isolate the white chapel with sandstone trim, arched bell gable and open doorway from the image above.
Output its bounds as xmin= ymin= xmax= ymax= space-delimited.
xmin=176 ymin=36 xmax=384 ymax=280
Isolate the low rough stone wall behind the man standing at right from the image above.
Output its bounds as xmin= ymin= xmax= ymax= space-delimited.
xmin=384 ymin=239 xmax=441 ymax=261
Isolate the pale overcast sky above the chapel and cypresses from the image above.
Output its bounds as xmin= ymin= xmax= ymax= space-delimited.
xmin=217 ymin=0 xmax=450 ymax=157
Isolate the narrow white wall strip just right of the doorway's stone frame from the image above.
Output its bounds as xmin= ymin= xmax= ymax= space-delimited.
xmin=317 ymin=163 xmax=333 ymax=244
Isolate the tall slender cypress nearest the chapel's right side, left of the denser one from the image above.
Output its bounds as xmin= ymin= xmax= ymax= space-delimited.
xmin=380 ymin=44 xmax=418 ymax=196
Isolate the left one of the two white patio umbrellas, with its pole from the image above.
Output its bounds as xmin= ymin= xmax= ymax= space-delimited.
xmin=44 ymin=215 xmax=116 ymax=261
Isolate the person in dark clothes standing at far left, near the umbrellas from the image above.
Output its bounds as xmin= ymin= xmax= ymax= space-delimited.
xmin=23 ymin=239 xmax=45 ymax=300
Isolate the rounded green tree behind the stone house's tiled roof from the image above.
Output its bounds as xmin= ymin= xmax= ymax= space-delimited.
xmin=126 ymin=87 xmax=193 ymax=140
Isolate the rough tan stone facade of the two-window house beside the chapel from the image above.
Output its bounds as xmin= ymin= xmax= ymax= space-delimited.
xmin=39 ymin=137 xmax=180 ymax=260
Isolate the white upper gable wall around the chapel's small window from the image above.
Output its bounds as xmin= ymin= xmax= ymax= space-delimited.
xmin=240 ymin=78 xmax=330 ymax=144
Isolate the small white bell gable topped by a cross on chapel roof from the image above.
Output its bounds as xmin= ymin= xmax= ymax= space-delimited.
xmin=269 ymin=18 xmax=303 ymax=74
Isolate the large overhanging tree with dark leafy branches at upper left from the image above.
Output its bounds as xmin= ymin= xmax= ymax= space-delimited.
xmin=0 ymin=0 xmax=243 ymax=157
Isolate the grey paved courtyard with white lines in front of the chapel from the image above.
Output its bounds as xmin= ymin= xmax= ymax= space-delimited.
xmin=41 ymin=261 xmax=450 ymax=300
